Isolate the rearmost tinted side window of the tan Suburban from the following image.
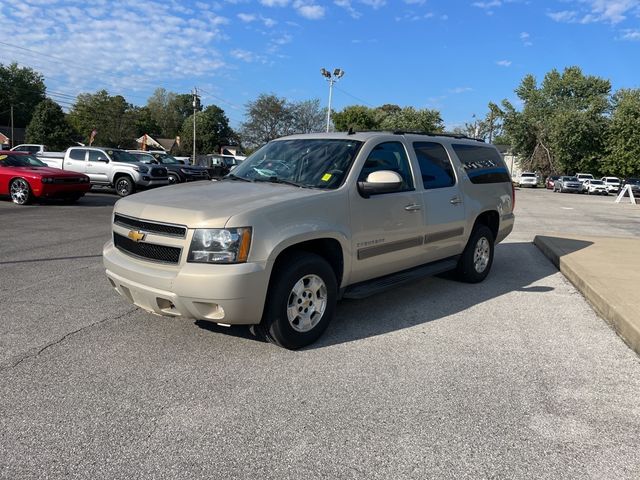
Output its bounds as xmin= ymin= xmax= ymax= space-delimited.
xmin=451 ymin=144 xmax=511 ymax=184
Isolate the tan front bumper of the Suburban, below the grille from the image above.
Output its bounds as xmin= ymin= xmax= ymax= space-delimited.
xmin=103 ymin=241 xmax=270 ymax=325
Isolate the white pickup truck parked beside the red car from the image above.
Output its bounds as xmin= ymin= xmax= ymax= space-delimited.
xmin=37 ymin=147 xmax=169 ymax=197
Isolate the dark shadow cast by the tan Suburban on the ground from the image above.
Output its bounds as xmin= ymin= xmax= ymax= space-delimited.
xmin=195 ymin=242 xmax=588 ymax=350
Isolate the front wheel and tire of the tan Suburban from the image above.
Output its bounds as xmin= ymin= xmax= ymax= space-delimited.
xmin=260 ymin=252 xmax=338 ymax=350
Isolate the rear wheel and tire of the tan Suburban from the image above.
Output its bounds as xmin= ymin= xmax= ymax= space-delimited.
xmin=456 ymin=224 xmax=495 ymax=283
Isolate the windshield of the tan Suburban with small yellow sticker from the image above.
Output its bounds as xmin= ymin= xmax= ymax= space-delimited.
xmin=232 ymin=138 xmax=362 ymax=189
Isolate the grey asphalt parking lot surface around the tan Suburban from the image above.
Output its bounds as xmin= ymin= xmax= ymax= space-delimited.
xmin=0 ymin=189 xmax=640 ymax=479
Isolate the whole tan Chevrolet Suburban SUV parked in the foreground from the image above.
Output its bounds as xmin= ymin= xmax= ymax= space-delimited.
xmin=104 ymin=131 xmax=514 ymax=349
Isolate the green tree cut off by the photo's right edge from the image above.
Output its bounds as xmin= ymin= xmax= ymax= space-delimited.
xmin=604 ymin=89 xmax=640 ymax=177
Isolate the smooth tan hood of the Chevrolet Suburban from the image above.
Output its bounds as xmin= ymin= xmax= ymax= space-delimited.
xmin=114 ymin=181 xmax=326 ymax=228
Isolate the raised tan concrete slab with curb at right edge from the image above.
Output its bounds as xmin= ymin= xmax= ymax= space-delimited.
xmin=533 ymin=234 xmax=640 ymax=355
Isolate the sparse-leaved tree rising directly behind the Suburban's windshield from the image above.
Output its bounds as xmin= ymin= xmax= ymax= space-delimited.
xmin=241 ymin=93 xmax=293 ymax=147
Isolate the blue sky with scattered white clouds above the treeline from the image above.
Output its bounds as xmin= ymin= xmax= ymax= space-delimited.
xmin=0 ymin=0 xmax=640 ymax=128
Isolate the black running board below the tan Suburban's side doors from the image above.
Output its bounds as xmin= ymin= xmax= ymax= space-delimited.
xmin=342 ymin=257 xmax=460 ymax=300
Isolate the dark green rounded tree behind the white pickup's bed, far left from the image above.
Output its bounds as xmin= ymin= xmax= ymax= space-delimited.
xmin=26 ymin=98 xmax=74 ymax=150
